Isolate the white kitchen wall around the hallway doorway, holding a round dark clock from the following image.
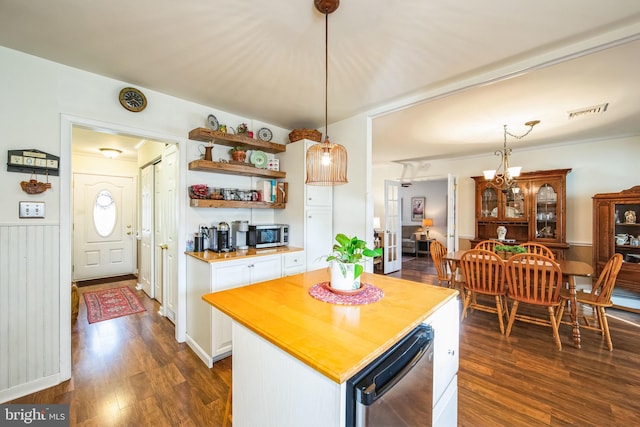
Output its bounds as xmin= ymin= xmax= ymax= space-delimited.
xmin=0 ymin=47 xmax=289 ymax=402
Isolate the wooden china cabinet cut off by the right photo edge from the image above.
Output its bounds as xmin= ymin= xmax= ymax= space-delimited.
xmin=593 ymin=185 xmax=640 ymax=292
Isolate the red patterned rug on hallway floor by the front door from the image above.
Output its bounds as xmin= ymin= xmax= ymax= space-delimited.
xmin=84 ymin=286 xmax=146 ymax=323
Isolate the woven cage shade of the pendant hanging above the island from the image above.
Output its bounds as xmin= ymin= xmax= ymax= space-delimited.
xmin=305 ymin=139 xmax=348 ymax=185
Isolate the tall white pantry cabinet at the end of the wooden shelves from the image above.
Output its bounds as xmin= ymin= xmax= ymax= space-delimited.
xmin=274 ymin=139 xmax=334 ymax=270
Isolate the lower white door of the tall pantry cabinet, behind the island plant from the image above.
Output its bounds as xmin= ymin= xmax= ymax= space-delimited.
xmin=304 ymin=208 xmax=333 ymax=271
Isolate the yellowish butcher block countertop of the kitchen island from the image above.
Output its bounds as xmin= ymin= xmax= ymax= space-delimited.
xmin=202 ymin=268 xmax=458 ymax=384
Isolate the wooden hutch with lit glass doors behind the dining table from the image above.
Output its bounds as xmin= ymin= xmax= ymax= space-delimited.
xmin=471 ymin=169 xmax=571 ymax=259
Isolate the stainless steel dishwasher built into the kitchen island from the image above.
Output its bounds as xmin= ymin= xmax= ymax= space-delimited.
xmin=346 ymin=324 xmax=433 ymax=427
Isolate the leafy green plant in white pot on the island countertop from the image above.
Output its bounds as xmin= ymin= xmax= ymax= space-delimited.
xmin=327 ymin=233 xmax=382 ymax=291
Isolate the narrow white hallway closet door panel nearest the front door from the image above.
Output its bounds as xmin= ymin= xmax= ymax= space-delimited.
xmin=138 ymin=165 xmax=154 ymax=298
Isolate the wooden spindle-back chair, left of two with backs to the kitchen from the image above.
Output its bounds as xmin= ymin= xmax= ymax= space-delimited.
xmin=460 ymin=249 xmax=508 ymax=334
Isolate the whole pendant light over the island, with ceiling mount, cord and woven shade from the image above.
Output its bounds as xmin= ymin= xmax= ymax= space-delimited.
xmin=305 ymin=0 xmax=347 ymax=185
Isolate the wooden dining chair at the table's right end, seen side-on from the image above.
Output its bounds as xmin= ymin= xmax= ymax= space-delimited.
xmin=557 ymin=254 xmax=622 ymax=351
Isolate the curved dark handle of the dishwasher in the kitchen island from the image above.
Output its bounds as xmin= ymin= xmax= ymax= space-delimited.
xmin=356 ymin=333 xmax=433 ymax=406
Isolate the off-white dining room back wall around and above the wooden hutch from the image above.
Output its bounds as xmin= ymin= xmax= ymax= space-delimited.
xmin=372 ymin=136 xmax=640 ymax=245
